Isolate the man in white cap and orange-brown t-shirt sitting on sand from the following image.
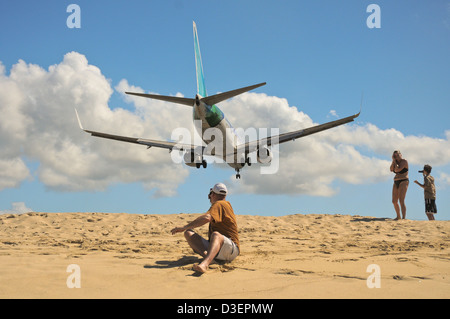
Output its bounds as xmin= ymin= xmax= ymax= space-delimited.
xmin=171 ymin=183 xmax=240 ymax=273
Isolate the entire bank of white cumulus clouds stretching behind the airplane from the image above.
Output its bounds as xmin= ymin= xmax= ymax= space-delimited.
xmin=0 ymin=52 xmax=450 ymax=196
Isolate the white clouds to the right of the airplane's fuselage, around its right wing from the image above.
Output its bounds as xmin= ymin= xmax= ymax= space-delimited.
xmin=222 ymin=93 xmax=450 ymax=196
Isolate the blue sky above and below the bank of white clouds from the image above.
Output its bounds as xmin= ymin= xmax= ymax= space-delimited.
xmin=0 ymin=0 xmax=450 ymax=219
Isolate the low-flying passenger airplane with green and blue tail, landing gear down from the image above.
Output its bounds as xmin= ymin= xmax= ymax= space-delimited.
xmin=75 ymin=21 xmax=361 ymax=179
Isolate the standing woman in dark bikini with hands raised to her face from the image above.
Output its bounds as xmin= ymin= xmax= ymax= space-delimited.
xmin=391 ymin=151 xmax=409 ymax=220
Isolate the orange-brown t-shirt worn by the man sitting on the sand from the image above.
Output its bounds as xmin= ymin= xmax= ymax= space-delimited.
xmin=208 ymin=200 xmax=241 ymax=250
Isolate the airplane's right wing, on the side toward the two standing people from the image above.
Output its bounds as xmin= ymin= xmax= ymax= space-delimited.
xmin=236 ymin=112 xmax=361 ymax=154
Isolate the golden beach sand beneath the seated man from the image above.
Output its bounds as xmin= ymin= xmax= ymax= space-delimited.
xmin=0 ymin=213 xmax=450 ymax=298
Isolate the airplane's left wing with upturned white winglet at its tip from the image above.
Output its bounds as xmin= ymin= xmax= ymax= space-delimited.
xmin=75 ymin=109 xmax=204 ymax=152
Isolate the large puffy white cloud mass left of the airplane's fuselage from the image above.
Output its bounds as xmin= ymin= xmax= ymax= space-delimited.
xmin=0 ymin=52 xmax=189 ymax=196
